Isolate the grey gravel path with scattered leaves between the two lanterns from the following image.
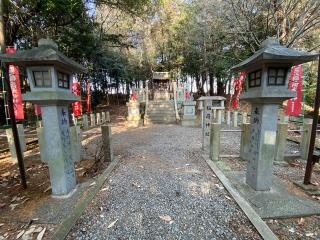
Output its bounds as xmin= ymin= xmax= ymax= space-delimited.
xmin=68 ymin=125 xmax=260 ymax=239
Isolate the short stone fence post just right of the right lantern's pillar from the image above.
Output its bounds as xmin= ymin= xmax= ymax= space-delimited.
xmin=274 ymin=122 xmax=288 ymax=162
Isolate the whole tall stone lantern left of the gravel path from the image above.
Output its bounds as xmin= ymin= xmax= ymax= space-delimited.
xmin=0 ymin=39 xmax=86 ymax=196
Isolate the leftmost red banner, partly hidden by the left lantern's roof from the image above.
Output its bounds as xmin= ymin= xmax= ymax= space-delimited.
xmin=6 ymin=47 xmax=24 ymax=120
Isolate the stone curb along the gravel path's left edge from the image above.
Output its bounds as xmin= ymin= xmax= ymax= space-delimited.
xmin=51 ymin=157 xmax=120 ymax=240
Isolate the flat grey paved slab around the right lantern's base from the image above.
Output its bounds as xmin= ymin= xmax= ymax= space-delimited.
xmin=225 ymin=171 xmax=320 ymax=218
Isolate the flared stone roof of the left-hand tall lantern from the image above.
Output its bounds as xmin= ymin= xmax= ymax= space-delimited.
xmin=0 ymin=39 xmax=87 ymax=73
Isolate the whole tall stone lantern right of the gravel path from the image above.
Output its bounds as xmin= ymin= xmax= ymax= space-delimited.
xmin=232 ymin=38 xmax=317 ymax=191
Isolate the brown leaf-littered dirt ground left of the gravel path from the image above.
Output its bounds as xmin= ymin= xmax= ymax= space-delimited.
xmin=0 ymin=107 xmax=126 ymax=240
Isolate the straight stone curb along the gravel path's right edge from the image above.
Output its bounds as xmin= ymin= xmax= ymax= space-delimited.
xmin=202 ymin=155 xmax=278 ymax=240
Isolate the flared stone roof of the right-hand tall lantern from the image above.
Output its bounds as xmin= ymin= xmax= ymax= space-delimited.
xmin=231 ymin=38 xmax=319 ymax=71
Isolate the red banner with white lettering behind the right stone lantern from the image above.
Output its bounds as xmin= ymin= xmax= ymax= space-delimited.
xmin=286 ymin=64 xmax=303 ymax=116
